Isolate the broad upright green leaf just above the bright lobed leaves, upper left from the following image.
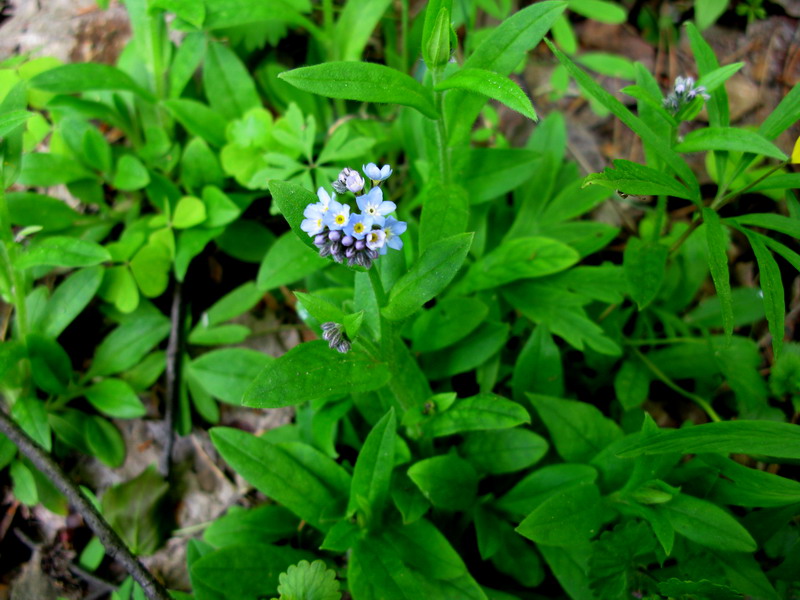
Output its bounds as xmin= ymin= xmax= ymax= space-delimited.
xmin=203 ymin=42 xmax=261 ymax=120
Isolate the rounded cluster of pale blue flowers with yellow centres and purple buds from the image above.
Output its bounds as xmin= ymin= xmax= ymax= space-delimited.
xmin=300 ymin=163 xmax=406 ymax=269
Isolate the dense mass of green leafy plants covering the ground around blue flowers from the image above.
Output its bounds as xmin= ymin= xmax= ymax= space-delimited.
xmin=0 ymin=0 xmax=800 ymax=600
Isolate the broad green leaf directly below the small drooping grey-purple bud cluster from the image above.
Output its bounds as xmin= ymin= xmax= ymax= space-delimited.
xmin=242 ymin=340 xmax=389 ymax=408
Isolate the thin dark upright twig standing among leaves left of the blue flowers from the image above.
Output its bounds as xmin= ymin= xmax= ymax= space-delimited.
xmin=160 ymin=281 xmax=184 ymax=479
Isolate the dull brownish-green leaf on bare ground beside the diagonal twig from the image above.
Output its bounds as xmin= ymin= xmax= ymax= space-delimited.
xmin=102 ymin=466 xmax=169 ymax=555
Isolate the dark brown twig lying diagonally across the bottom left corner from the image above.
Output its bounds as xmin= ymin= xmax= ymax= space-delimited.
xmin=0 ymin=409 xmax=170 ymax=600
